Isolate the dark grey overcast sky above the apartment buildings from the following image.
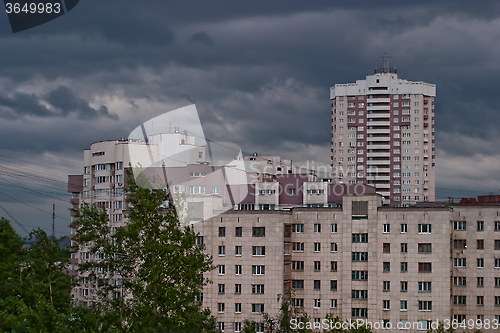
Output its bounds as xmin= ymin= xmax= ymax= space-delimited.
xmin=0 ymin=0 xmax=500 ymax=236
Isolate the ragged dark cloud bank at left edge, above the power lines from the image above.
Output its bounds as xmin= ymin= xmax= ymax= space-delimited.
xmin=0 ymin=86 xmax=118 ymax=120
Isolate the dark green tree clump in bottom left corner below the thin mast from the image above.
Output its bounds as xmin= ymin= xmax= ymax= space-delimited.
xmin=0 ymin=219 xmax=79 ymax=332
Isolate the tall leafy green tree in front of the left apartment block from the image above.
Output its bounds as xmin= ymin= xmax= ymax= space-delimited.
xmin=73 ymin=172 xmax=216 ymax=332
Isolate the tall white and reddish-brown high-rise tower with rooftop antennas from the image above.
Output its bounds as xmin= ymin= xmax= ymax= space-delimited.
xmin=330 ymin=57 xmax=436 ymax=206
